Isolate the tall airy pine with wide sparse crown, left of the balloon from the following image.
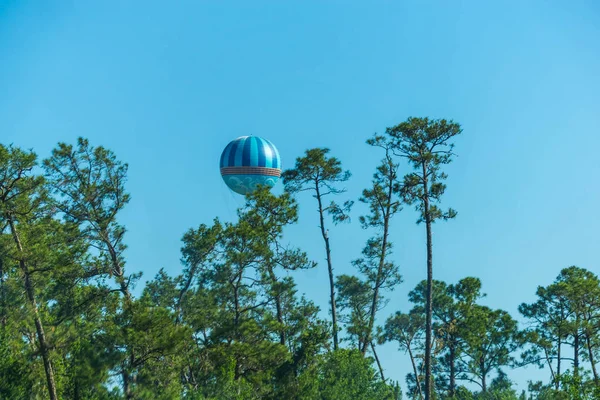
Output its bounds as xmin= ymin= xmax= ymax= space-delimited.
xmin=44 ymin=138 xmax=139 ymax=399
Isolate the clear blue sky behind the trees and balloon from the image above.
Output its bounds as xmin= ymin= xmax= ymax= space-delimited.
xmin=0 ymin=0 xmax=600 ymax=394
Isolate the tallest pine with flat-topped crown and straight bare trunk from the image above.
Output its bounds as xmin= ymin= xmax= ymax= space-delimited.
xmin=386 ymin=117 xmax=462 ymax=400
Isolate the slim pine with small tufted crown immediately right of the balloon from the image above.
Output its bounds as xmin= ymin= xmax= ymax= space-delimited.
xmin=282 ymin=148 xmax=352 ymax=349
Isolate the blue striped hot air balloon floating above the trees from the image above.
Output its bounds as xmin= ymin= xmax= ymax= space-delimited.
xmin=221 ymin=136 xmax=281 ymax=195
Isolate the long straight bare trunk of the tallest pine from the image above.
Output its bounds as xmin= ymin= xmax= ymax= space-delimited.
xmin=423 ymin=163 xmax=433 ymax=400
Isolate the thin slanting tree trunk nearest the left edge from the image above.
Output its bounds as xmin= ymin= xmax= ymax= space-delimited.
xmin=7 ymin=215 xmax=58 ymax=400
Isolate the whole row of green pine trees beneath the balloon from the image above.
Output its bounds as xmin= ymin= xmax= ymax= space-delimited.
xmin=0 ymin=118 xmax=600 ymax=400
